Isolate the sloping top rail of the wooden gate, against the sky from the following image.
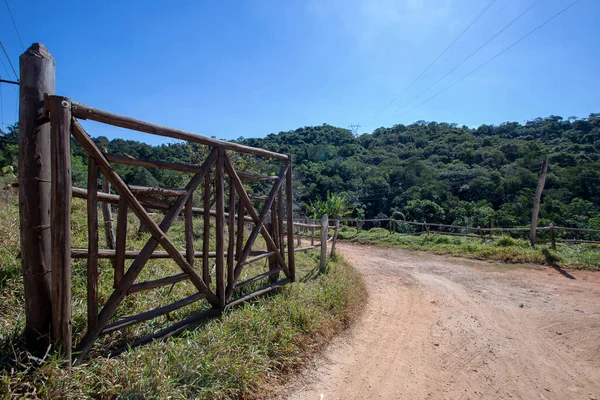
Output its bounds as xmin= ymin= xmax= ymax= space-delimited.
xmin=71 ymin=102 xmax=289 ymax=160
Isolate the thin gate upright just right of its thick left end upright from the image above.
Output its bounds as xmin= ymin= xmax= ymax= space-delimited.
xmin=87 ymin=157 xmax=98 ymax=331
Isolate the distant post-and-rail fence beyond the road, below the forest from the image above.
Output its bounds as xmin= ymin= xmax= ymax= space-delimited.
xmin=332 ymin=218 xmax=600 ymax=247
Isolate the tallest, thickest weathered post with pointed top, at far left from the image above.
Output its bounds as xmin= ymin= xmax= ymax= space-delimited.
xmin=19 ymin=43 xmax=56 ymax=355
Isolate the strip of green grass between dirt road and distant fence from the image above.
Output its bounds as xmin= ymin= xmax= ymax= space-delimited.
xmin=339 ymin=227 xmax=600 ymax=270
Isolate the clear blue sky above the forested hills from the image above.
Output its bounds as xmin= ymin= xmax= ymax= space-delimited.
xmin=0 ymin=0 xmax=600 ymax=144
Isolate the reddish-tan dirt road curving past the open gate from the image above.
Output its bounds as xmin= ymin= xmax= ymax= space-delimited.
xmin=287 ymin=244 xmax=600 ymax=400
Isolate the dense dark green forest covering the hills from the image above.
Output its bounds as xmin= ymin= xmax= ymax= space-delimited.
xmin=0 ymin=114 xmax=600 ymax=228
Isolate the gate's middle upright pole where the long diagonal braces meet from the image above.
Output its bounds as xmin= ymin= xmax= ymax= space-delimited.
xmin=215 ymin=148 xmax=225 ymax=308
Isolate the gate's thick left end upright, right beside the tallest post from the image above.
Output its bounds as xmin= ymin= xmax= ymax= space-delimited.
xmin=48 ymin=96 xmax=72 ymax=365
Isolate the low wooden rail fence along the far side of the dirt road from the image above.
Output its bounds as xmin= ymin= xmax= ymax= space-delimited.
xmin=342 ymin=218 xmax=600 ymax=248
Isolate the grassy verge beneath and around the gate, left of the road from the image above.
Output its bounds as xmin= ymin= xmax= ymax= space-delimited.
xmin=0 ymin=191 xmax=365 ymax=399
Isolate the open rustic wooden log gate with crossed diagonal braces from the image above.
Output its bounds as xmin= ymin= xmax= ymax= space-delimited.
xmin=44 ymin=96 xmax=295 ymax=362
